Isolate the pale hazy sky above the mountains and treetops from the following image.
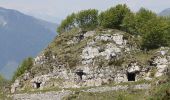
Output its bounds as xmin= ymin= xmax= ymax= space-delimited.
xmin=0 ymin=0 xmax=170 ymax=21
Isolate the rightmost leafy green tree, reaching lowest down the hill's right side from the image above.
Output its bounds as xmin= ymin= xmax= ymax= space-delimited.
xmin=141 ymin=17 xmax=169 ymax=49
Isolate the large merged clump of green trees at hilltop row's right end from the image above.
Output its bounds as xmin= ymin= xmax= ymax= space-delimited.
xmin=122 ymin=8 xmax=170 ymax=50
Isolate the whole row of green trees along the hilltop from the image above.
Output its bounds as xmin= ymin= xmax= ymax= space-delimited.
xmin=57 ymin=5 xmax=170 ymax=50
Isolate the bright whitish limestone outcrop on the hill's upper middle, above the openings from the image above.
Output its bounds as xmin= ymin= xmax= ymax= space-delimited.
xmin=81 ymin=34 xmax=127 ymax=64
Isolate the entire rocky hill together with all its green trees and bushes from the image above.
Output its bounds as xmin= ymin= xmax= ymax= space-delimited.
xmin=7 ymin=5 xmax=170 ymax=100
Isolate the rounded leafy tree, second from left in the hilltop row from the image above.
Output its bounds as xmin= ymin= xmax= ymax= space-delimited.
xmin=76 ymin=9 xmax=98 ymax=30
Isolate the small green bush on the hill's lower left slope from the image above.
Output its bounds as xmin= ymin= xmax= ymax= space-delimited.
xmin=12 ymin=57 xmax=33 ymax=81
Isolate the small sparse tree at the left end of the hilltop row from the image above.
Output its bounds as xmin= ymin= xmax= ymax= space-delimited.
xmin=57 ymin=13 xmax=76 ymax=33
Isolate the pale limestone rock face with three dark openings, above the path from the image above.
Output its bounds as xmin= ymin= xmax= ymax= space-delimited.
xmin=11 ymin=30 xmax=170 ymax=92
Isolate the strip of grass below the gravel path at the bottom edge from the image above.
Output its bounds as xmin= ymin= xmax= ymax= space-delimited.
xmin=63 ymin=90 xmax=146 ymax=100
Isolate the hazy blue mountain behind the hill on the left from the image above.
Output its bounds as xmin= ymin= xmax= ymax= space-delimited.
xmin=0 ymin=7 xmax=57 ymax=78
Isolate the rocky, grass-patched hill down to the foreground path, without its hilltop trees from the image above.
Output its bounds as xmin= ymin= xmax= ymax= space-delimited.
xmin=11 ymin=28 xmax=170 ymax=100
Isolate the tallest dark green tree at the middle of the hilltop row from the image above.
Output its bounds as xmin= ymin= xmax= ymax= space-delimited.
xmin=99 ymin=4 xmax=131 ymax=29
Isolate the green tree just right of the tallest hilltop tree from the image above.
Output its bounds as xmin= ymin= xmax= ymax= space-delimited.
xmin=122 ymin=8 xmax=157 ymax=35
